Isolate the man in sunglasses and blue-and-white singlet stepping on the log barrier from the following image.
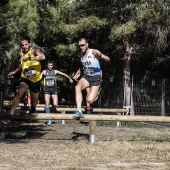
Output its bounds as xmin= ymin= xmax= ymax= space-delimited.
xmin=73 ymin=38 xmax=110 ymax=118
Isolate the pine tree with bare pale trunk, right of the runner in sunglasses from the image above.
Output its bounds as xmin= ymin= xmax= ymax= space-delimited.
xmin=110 ymin=0 xmax=169 ymax=114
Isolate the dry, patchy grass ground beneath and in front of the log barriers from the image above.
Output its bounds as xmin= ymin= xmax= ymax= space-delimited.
xmin=0 ymin=121 xmax=170 ymax=170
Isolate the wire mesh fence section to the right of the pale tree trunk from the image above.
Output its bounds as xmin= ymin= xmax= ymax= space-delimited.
xmin=133 ymin=78 xmax=170 ymax=116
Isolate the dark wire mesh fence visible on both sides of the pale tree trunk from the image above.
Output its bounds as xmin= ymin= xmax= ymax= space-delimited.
xmin=96 ymin=75 xmax=170 ymax=116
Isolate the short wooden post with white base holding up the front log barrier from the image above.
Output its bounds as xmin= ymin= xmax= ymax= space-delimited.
xmin=89 ymin=120 xmax=96 ymax=143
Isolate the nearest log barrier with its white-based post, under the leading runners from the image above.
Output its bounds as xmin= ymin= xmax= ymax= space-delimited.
xmin=11 ymin=113 xmax=170 ymax=143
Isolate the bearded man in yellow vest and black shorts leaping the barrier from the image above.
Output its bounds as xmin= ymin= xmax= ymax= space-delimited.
xmin=2 ymin=37 xmax=45 ymax=124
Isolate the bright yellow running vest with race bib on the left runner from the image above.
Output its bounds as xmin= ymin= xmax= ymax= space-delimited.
xmin=21 ymin=48 xmax=42 ymax=82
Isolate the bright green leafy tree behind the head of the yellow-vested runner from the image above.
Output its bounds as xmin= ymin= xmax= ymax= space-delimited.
xmin=0 ymin=0 xmax=39 ymax=95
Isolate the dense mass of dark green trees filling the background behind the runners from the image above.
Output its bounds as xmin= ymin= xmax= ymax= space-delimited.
xmin=0 ymin=0 xmax=170 ymax=105
